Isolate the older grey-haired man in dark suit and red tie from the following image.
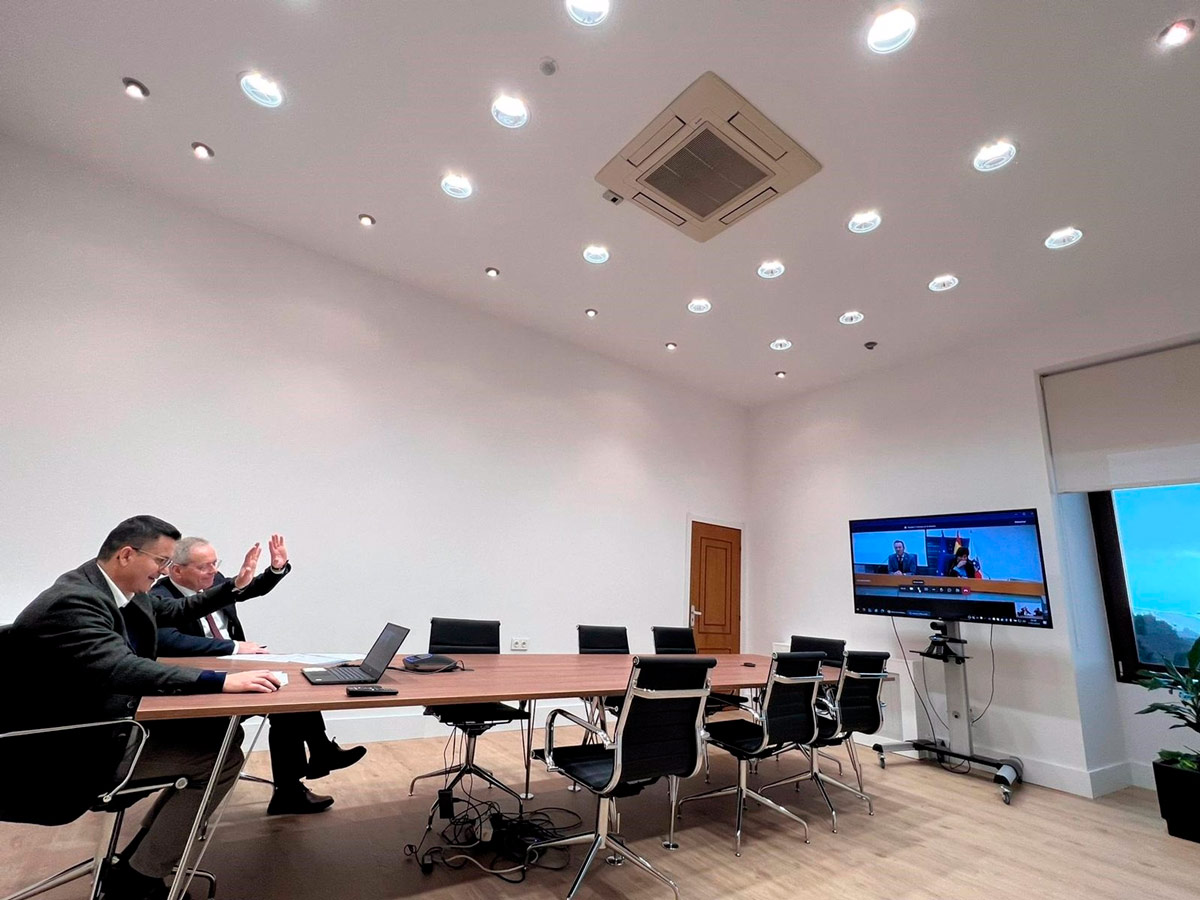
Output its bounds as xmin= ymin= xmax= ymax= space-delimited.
xmin=150 ymin=538 xmax=366 ymax=816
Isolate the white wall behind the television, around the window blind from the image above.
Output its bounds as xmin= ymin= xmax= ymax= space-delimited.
xmin=750 ymin=309 xmax=1200 ymax=794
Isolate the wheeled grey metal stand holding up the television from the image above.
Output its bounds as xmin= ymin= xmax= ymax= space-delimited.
xmin=872 ymin=620 xmax=1024 ymax=804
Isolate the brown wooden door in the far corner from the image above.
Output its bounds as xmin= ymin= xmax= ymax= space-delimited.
xmin=690 ymin=522 xmax=742 ymax=654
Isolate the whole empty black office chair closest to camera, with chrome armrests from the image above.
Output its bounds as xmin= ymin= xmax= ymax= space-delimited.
xmin=526 ymin=656 xmax=716 ymax=900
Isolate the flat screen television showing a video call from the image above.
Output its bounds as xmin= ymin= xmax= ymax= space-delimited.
xmin=850 ymin=509 xmax=1052 ymax=628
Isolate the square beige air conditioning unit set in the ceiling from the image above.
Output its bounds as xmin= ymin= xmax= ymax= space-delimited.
xmin=596 ymin=72 xmax=821 ymax=241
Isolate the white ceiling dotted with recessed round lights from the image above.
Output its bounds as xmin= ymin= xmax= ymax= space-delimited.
xmin=0 ymin=0 xmax=1200 ymax=404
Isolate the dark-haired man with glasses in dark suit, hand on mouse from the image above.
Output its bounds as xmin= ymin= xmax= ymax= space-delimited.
xmin=5 ymin=516 xmax=288 ymax=900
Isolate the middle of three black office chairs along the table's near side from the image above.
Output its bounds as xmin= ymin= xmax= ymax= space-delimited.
xmin=679 ymin=650 xmax=824 ymax=856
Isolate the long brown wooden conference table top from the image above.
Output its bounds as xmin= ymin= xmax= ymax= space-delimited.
xmin=137 ymin=653 xmax=838 ymax=721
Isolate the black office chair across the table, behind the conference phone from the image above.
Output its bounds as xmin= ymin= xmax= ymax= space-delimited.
xmin=408 ymin=617 xmax=529 ymax=815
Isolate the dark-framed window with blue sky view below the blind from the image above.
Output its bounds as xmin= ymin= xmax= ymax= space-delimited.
xmin=1088 ymin=484 xmax=1200 ymax=682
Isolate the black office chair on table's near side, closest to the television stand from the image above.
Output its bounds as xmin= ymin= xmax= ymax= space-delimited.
xmin=760 ymin=650 xmax=890 ymax=833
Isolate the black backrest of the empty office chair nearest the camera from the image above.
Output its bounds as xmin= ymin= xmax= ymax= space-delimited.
xmin=613 ymin=656 xmax=716 ymax=784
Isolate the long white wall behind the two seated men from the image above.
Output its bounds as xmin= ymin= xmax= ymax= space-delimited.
xmin=0 ymin=137 xmax=746 ymax=681
